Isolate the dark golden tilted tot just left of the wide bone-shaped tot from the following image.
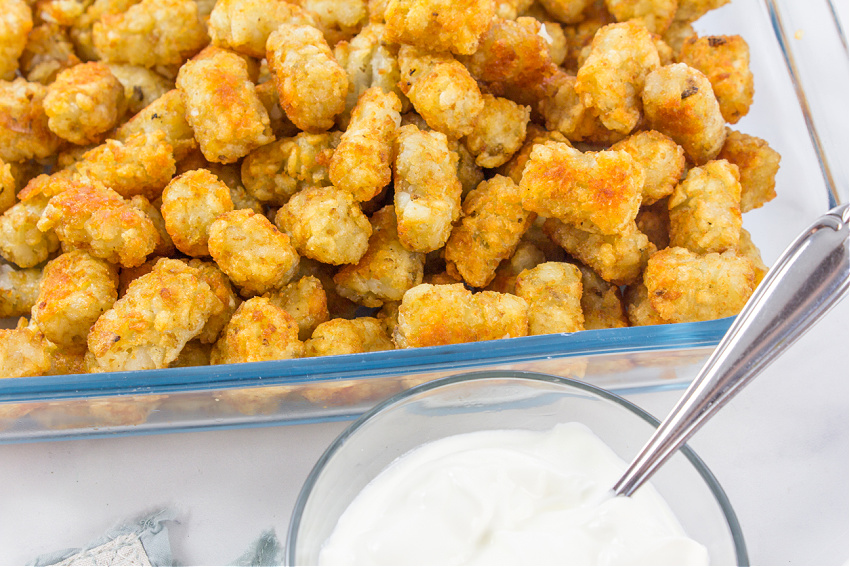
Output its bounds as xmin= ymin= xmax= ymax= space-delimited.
xmin=445 ymin=175 xmax=536 ymax=287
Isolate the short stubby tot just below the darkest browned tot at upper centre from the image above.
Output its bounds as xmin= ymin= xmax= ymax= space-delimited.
xmin=465 ymin=95 xmax=531 ymax=168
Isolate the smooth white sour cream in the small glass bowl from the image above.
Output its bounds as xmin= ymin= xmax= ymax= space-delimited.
xmin=319 ymin=423 xmax=708 ymax=565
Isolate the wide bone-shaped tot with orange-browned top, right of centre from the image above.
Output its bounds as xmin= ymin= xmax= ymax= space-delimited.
xmin=520 ymin=142 xmax=644 ymax=234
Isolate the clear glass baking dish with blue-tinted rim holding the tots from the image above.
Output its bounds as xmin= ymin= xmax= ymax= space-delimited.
xmin=0 ymin=0 xmax=836 ymax=443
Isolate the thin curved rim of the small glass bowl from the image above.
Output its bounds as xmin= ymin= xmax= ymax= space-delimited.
xmin=284 ymin=370 xmax=749 ymax=565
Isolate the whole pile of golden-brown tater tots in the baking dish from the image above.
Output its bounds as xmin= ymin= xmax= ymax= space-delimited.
xmin=0 ymin=0 xmax=779 ymax=377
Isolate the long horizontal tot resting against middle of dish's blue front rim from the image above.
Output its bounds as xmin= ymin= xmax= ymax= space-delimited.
xmin=393 ymin=283 xmax=528 ymax=348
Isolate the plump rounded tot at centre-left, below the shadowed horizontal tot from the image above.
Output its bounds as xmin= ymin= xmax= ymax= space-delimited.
xmin=275 ymin=187 xmax=372 ymax=266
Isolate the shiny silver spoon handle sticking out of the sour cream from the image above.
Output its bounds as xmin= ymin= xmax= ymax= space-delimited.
xmin=614 ymin=204 xmax=850 ymax=496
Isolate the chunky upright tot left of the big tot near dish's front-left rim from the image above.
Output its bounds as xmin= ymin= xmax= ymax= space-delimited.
xmin=32 ymin=250 xmax=118 ymax=350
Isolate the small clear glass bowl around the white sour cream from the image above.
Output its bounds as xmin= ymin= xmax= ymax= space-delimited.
xmin=286 ymin=371 xmax=749 ymax=565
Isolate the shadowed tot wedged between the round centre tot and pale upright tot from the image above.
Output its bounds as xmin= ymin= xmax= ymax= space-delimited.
xmin=334 ymin=205 xmax=425 ymax=307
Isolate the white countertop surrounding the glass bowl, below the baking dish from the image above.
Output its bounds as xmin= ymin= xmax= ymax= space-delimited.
xmin=0 ymin=299 xmax=850 ymax=565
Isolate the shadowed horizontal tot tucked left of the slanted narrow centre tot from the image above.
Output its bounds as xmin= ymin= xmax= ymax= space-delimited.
xmin=241 ymin=131 xmax=342 ymax=206
